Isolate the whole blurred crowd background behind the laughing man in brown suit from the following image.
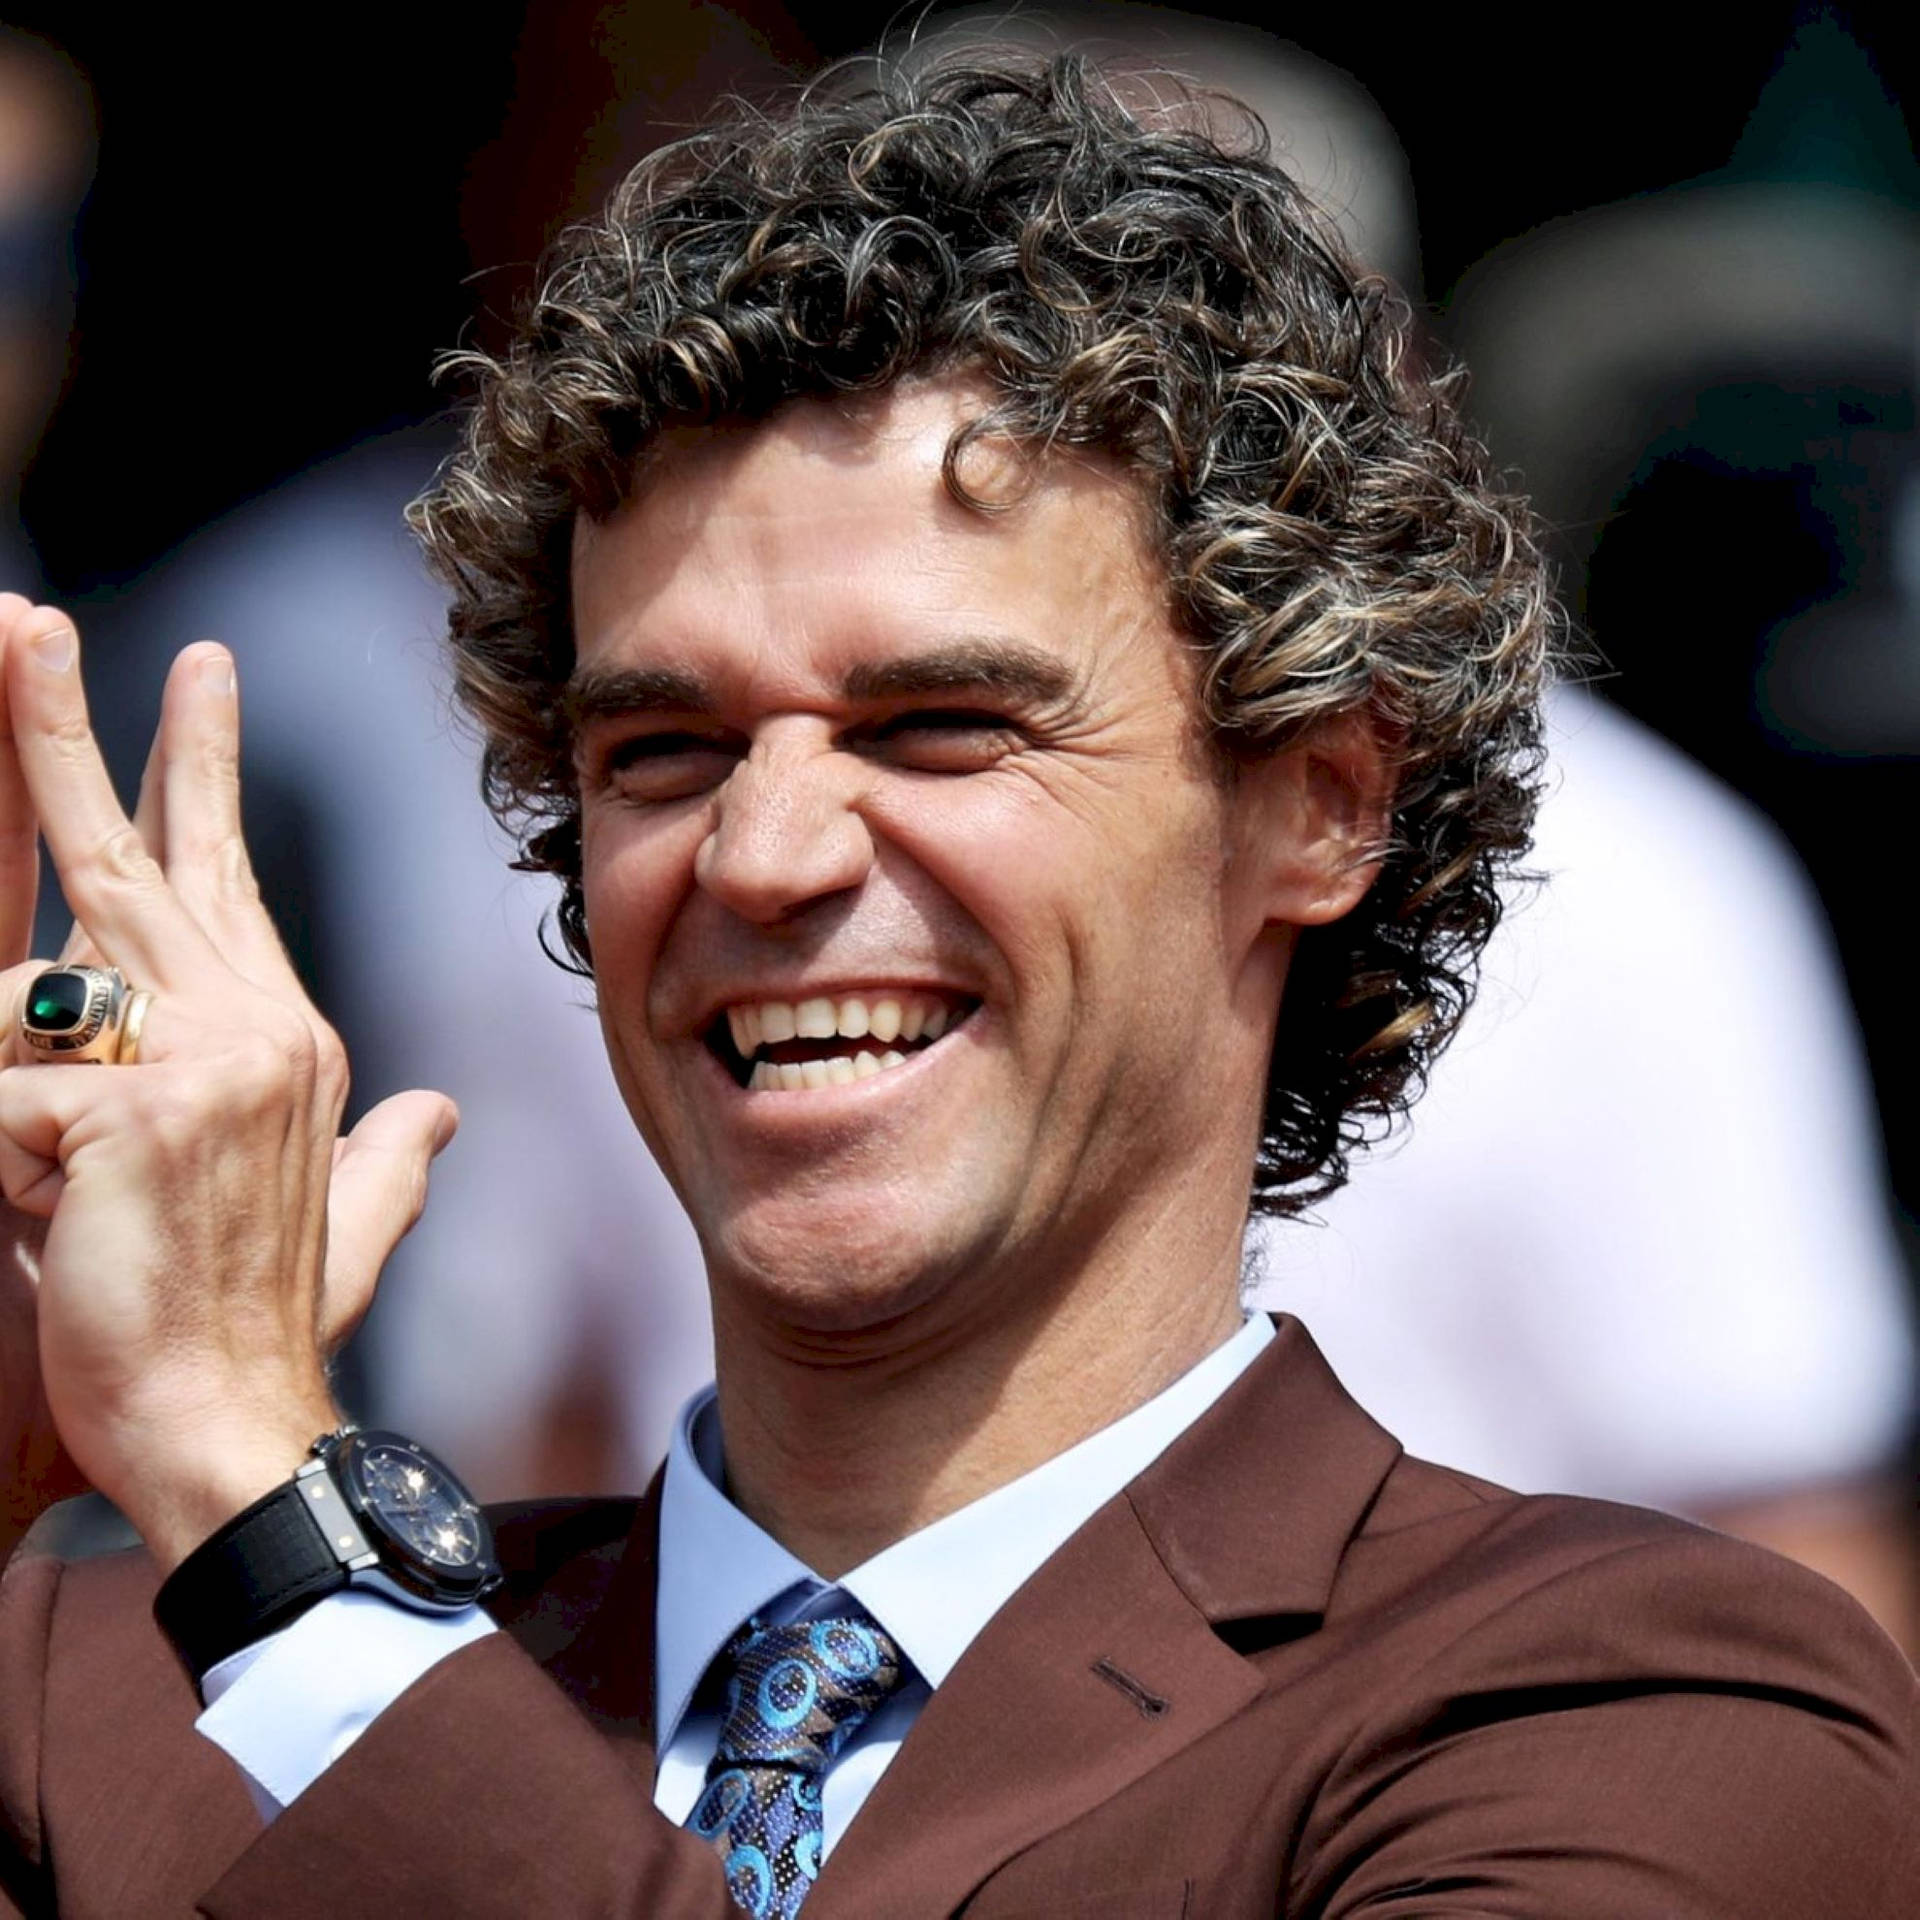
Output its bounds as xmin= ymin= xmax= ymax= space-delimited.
xmin=0 ymin=0 xmax=1920 ymax=1645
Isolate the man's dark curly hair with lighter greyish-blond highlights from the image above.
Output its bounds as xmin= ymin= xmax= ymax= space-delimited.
xmin=411 ymin=50 xmax=1557 ymax=1213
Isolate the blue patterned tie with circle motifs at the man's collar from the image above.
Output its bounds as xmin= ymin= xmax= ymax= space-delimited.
xmin=687 ymin=1613 xmax=900 ymax=1920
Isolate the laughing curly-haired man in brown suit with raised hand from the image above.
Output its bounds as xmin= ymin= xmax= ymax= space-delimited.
xmin=0 ymin=61 xmax=1916 ymax=1920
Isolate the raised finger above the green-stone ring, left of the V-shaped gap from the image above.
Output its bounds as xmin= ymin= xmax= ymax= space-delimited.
xmin=6 ymin=607 xmax=219 ymax=987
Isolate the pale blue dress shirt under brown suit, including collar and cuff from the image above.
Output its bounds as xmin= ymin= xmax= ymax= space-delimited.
xmin=198 ymin=1315 xmax=1273 ymax=1857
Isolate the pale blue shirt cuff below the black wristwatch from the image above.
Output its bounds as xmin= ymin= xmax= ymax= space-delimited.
xmin=194 ymin=1592 xmax=497 ymax=1820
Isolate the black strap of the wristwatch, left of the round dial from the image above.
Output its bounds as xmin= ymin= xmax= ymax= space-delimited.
xmin=154 ymin=1473 xmax=367 ymax=1686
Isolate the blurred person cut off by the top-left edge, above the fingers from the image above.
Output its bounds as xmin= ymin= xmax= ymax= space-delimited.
xmin=0 ymin=25 xmax=94 ymax=595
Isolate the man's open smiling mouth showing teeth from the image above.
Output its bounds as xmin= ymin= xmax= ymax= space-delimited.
xmin=705 ymin=989 xmax=979 ymax=1092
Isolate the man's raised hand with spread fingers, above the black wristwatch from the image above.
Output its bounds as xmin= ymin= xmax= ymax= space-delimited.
xmin=0 ymin=599 xmax=453 ymax=1569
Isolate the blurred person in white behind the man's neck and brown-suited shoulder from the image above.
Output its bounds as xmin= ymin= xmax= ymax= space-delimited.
xmin=1265 ymin=691 xmax=1920 ymax=1647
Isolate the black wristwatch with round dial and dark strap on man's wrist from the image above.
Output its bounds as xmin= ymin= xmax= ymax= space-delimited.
xmin=154 ymin=1427 xmax=501 ymax=1686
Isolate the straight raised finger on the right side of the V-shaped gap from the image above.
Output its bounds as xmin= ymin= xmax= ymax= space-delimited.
xmin=156 ymin=641 xmax=301 ymax=995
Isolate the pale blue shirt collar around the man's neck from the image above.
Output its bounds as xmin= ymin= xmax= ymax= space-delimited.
xmin=655 ymin=1313 xmax=1273 ymax=1753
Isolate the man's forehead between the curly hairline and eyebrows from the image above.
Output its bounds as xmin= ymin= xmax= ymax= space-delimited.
xmin=574 ymin=382 xmax=1183 ymax=693
